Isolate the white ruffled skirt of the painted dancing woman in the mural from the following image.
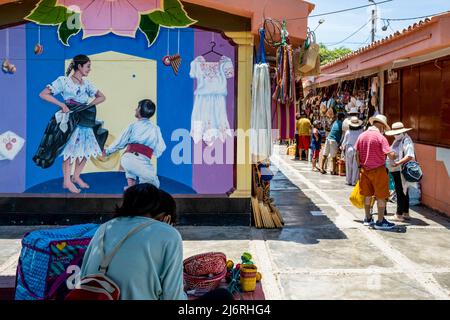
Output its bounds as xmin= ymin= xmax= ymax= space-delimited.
xmin=62 ymin=126 xmax=102 ymax=163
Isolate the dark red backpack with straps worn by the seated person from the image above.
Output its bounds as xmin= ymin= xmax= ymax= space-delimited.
xmin=65 ymin=221 xmax=153 ymax=300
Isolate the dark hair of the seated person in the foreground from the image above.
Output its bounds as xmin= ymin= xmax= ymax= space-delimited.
xmin=114 ymin=183 xmax=176 ymax=223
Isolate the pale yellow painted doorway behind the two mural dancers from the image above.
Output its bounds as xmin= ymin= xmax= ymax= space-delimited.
xmin=66 ymin=51 xmax=158 ymax=173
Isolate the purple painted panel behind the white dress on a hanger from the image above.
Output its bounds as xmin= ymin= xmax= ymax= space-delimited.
xmin=192 ymin=30 xmax=237 ymax=194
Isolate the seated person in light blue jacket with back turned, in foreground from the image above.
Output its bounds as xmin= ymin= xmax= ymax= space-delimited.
xmin=81 ymin=183 xmax=187 ymax=300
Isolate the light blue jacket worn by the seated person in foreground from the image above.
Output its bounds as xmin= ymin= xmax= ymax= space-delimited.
xmin=81 ymin=217 xmax=187 ymax=300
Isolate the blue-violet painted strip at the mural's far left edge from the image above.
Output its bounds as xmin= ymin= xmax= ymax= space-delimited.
xmin=0 ymin=25 xmax=27 ymax=193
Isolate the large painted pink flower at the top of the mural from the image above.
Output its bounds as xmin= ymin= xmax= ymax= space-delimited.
xmin=57 ymin=0 xmax=161 ymax=38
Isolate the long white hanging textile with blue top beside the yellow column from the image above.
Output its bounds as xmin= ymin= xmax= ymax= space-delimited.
xmin=250 ymin=29 xmax=272 ymax=163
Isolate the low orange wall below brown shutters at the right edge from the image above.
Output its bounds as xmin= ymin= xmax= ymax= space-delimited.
xmin=415 ymin=143 xmax=450 ymax=216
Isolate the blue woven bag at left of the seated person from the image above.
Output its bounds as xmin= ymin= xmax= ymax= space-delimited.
xmin=15 ymin=224 xmax=99 ymax=300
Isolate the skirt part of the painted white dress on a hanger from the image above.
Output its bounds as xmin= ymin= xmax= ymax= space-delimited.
xmin=191 ymin=95 xmax=233 ymax=145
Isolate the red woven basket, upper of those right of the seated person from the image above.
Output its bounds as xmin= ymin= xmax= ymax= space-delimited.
xmin=183 ymin=252 xmax=227 ymax=276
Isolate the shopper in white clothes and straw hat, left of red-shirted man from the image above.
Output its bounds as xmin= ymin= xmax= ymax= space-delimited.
xmin=341 ymin=117 xmax=364 ymax=186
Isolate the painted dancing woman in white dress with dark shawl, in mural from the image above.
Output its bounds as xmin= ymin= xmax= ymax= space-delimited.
xmin=33 ymin=55 xmax=107 ymax=193
